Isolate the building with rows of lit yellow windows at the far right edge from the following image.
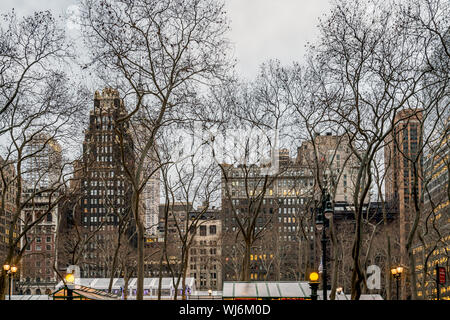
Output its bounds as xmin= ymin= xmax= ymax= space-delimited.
xmin=413 ymin=119 xmax=450 ymax=300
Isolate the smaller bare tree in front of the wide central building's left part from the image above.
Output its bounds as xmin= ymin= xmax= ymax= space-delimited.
xmin=212 ymin=61 xmax=288 ymax=281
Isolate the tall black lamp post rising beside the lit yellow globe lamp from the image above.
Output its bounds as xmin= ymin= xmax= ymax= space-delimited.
xmin=316 ymin=189 xmax=334 ymax=300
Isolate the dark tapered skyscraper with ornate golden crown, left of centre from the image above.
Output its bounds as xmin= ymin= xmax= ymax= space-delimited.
xmin=80 ymin=88 xmax=134 ymax=277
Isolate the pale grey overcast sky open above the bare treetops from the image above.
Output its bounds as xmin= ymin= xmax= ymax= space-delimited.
xmin=0 ymin=0 xmax=330 ymax=80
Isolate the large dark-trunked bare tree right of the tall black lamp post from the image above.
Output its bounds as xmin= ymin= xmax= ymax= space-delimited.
xmin=308 ymin=1 xmax=444 ymax=299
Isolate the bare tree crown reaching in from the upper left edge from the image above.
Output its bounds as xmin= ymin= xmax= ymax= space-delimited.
xmin=0 ymin=11 xmax=69 ymax=117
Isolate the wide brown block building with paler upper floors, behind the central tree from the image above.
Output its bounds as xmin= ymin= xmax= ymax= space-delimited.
xmin=221 ymin=149 xmax=318 ymax=281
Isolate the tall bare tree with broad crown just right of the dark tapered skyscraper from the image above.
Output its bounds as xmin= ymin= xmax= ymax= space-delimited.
xmin=82 ymin=0 xmax=232 ymax=300
